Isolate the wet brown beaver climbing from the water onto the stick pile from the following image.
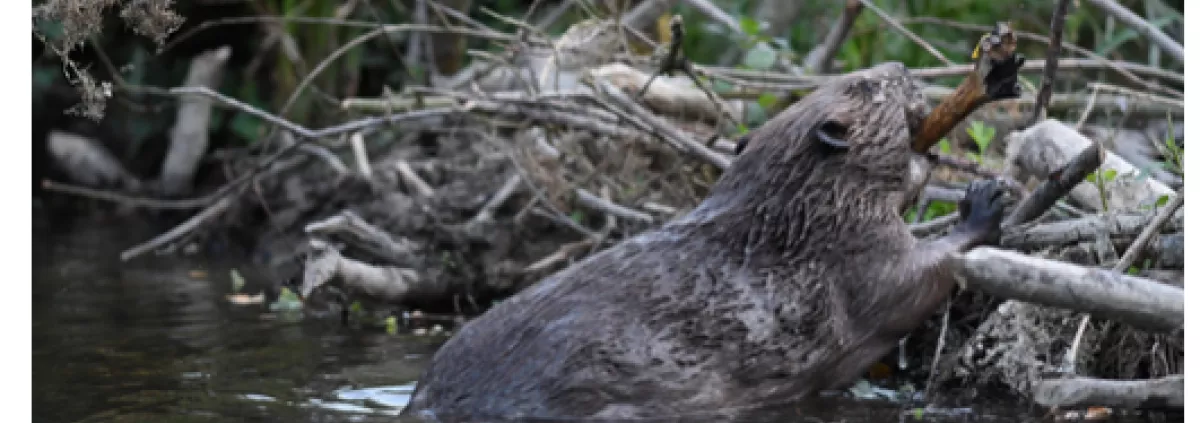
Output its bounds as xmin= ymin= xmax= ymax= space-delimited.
xmin=406 ymin=62 xmax=1003 ymax=421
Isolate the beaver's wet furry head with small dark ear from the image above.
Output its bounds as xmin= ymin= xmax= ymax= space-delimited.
xmin=690 ymin=62 xmax=929 ymax=252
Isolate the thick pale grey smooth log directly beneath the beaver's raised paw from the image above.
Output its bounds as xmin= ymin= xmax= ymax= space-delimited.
xmin=950 ymin=248 xmax=1183 ymax=332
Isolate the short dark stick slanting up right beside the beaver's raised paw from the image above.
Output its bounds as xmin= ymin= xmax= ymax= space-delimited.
xmin=1001 ymin=142 xmax=1104 ymax=227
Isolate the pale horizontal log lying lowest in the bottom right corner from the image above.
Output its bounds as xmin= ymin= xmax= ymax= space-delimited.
xmin=1032 ymin=375 xmax=1183 ymax=409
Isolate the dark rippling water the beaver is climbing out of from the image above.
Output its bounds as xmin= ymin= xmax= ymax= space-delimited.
xmin=32 ymin=216 xmax=1176 ymax=423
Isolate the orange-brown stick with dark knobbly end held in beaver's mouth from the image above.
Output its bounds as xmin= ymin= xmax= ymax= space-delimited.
xmin=912 ymin=22 xmax=1025 ymax=153
